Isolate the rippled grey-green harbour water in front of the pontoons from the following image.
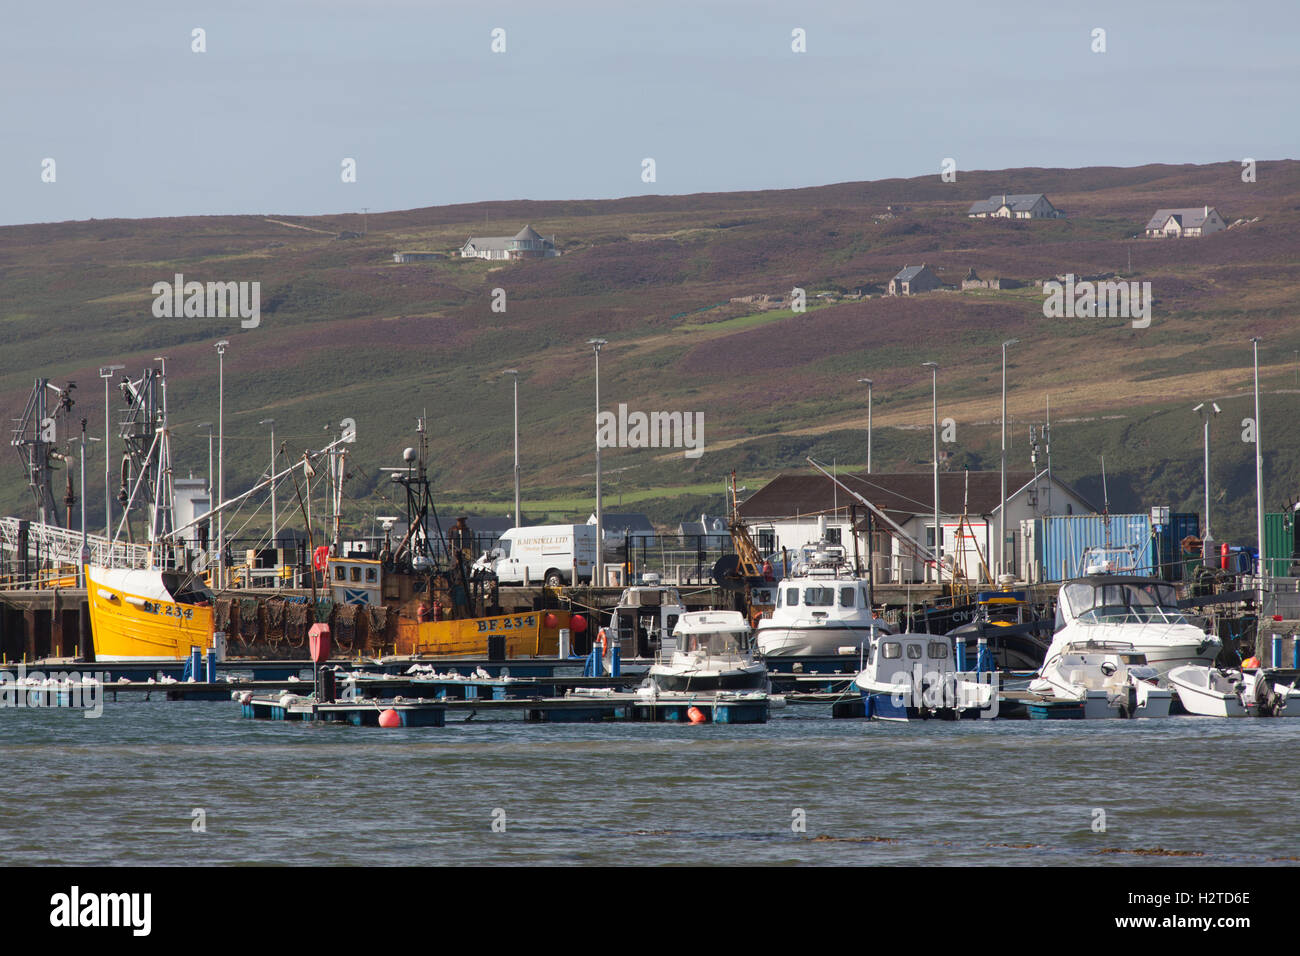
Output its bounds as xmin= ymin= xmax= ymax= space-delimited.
xmin=0 ymin=701 xmax=1300 ymax=866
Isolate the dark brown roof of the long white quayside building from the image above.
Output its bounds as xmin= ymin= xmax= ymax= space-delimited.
xmin=740 ymin=471 xmax=1087 ymax=520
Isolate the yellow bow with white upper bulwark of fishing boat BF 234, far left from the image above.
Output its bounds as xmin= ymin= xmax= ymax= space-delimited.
xmin=86 ymin=564 xmax=213 ymax=662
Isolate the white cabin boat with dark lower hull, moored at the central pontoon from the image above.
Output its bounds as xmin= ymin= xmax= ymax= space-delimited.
xmin=649 ymin=611 xmax=771 ymax=693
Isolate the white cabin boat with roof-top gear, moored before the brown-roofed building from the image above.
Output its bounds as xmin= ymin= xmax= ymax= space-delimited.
xmin=755 ymin=542 xmax=892 ymax=657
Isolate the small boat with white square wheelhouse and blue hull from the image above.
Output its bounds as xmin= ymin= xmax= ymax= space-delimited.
xmin=853 ymin=633 xmax=997 ymax=721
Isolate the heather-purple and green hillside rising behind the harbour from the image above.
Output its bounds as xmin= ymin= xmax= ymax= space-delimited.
xmin=0 ymin=160 xmax=1300 ymax=536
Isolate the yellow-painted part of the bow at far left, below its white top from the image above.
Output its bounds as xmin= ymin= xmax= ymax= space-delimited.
xmin=86 ymin=568 xmax=213 ymax=661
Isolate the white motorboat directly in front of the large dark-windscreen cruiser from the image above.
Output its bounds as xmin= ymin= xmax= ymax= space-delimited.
xmin=1028 ymin=644 xmax=1174 ymax=718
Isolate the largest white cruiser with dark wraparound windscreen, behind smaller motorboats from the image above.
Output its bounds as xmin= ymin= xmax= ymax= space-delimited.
xmin=1045 ymin=574 xmax=1222 ymax=683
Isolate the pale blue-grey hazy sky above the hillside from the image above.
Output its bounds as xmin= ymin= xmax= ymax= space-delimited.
xmin=0 ymin=0 xmax=1300 ymax=224
